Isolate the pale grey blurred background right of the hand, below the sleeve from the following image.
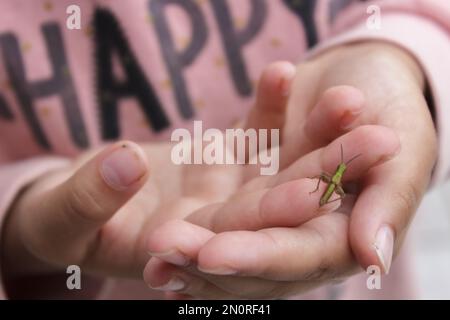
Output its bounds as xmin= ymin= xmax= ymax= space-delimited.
xmin=409 ymin=183 xmax=450 ymax=299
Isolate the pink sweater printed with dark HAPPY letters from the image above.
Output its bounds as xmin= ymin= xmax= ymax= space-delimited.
xmin=0 ymin=0 xmax=450 ymax=298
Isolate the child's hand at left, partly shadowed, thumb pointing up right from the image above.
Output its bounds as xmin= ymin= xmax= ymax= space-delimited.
xmin=1 ymin=63 xmax=295 ymax=284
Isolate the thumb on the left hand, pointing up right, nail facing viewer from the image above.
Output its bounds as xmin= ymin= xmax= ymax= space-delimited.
xmin=22 ymin=142 xmax=149 ymax=263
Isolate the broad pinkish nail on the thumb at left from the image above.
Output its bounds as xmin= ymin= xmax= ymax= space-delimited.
xmin=100 ymin=144 xmax=146 ymax=190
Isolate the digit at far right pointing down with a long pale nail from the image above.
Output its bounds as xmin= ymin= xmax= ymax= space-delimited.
xmin=349 ymin=131 xmax=436 ymax=274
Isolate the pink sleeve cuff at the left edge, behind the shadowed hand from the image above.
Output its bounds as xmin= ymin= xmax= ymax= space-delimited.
xmin=0 ymin=157 xmax=68 ymax=299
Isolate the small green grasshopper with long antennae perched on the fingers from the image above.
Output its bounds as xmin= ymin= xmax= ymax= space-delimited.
xmin=309 ymin=144 xmax=361 ymax=207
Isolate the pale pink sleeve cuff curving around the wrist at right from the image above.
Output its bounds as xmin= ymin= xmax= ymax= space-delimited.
xmin=311 ymin=0 xmax=450 ymax=184
